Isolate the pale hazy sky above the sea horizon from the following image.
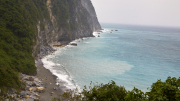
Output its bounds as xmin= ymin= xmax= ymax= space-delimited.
xmin=91 ymin=0 xmax=180 ymax=27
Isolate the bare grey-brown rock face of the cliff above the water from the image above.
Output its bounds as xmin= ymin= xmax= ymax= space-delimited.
xmin=33 ymin=0 xmax=101 ymax=57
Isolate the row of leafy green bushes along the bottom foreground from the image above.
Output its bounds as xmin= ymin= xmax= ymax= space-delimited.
xmin=53 ymin=77 xmax=180 ymax=101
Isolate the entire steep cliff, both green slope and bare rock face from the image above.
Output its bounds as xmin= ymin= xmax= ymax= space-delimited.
xmin=0 ymin=0 xmax=101 ymax=94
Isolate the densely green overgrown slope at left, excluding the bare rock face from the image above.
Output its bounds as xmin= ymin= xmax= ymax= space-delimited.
xmin=0 ymin=0 xmax=49 ymax=91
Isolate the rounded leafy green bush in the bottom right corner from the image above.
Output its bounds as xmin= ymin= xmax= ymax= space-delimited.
xmin=147 ymin=77 xmax=180 ymax=101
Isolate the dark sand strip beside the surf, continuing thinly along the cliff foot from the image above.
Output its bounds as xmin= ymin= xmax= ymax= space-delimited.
xmin=35 ymin=31 xmax=103 ymax=101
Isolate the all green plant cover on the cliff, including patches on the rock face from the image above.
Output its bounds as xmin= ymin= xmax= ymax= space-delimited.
xmin=0 ymin=0 xmax=95 ymax=91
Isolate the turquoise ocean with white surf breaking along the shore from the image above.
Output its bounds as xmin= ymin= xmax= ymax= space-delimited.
xmin=42 ymin=24 xmax=180 ymax=92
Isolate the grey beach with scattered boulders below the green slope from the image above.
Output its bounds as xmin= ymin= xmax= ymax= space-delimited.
xmin=5 ymin=59 xmax=63 ymax=101
